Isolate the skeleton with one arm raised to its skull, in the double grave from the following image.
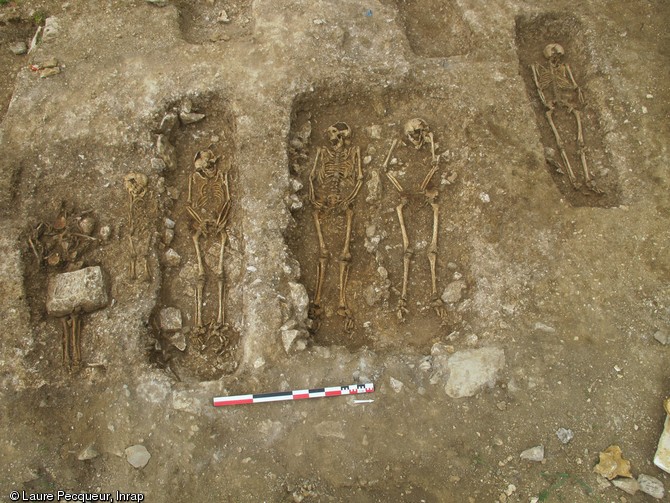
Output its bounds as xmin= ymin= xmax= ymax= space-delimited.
xmin=383 ymin=118 xmax=446 ymax=322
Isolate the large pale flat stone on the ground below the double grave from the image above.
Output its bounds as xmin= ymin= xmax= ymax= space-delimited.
xmin=445 ymin=348 xmax=505 ymax=398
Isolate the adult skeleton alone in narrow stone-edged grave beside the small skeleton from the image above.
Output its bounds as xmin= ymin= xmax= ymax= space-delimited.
xmin=186 ymin=149 xmax=230 ymax=328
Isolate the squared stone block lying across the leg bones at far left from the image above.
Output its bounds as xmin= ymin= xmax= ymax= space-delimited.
xmin=47 ymin=266 xmax=109 ymax=317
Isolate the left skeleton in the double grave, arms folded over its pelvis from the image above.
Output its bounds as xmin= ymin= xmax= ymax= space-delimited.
xmin=309 ymin=122 xmax=363 ymax=331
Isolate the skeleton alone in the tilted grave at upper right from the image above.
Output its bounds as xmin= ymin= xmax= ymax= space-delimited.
xmin=531 ymin=43 xmax=602 ymax=194
